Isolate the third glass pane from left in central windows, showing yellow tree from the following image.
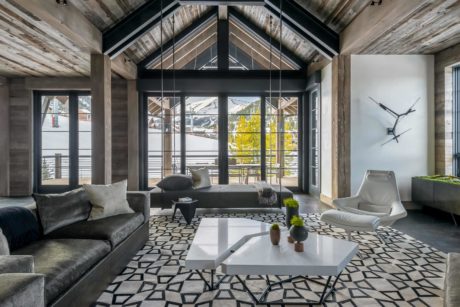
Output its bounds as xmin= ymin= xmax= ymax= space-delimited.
xmin=228 ymin=97 xmax=262 ymax=184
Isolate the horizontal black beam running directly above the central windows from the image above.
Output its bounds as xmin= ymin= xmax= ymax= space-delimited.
xmin=137 ymin=70 xmax=307 ymax=95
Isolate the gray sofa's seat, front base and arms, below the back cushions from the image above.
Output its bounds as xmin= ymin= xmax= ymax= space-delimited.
xmin=0 ymin=192 xmax=150 ymax=307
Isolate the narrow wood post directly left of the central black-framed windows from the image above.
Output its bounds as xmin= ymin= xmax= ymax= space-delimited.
xmin=127 ymin=80 xmax=140 ymax=191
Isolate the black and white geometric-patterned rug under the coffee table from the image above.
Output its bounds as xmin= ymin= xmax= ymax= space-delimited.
xmin=95 ymin=213 xmax=446 ymax=307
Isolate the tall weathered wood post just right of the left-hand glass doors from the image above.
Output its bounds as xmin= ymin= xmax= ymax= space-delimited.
xmin=91 ymin=54 xmax=112 ymax=184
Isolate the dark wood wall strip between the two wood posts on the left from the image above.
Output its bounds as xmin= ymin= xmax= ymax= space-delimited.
xmin=112 ymin=80 xmax=128 ymax=182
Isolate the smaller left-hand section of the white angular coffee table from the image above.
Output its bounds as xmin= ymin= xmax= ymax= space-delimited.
xmin=185 ymin=218 xmax=270 ymax=290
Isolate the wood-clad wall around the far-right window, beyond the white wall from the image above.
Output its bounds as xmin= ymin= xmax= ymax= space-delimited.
xmin=434 ymin=44 xmax=460 ymax=175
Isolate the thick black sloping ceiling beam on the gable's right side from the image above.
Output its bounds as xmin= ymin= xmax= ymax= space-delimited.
xmin=265 ymin=0 xmax=340 ymax=59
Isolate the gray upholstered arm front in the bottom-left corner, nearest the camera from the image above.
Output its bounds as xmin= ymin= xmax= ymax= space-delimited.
xmin=0 ymin=273 xmax=45 ymax=307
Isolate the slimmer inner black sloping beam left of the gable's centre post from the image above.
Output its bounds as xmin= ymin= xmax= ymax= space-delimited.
xmin=137 ymin=7 xmax=217 ymax=70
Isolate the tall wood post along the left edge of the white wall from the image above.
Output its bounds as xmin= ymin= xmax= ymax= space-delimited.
xmin=332 ymin=55 xmax=351 ymax=199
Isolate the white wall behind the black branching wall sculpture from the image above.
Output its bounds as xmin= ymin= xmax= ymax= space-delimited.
xmin=351 ymin=55 xmax=434 ymax=201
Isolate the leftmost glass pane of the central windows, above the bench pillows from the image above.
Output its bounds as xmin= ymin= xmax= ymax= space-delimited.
xmin=147 ymin=97 xmax=181 ymax=187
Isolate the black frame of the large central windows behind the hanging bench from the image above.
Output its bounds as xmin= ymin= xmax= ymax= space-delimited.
xmin=139 ymin=91 xmax=308 ymax=192
